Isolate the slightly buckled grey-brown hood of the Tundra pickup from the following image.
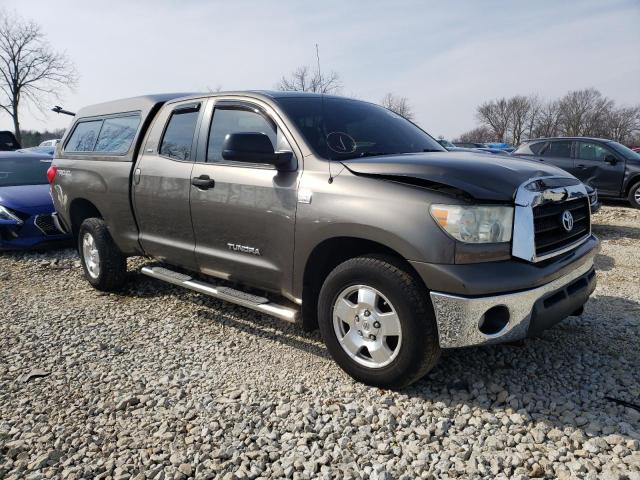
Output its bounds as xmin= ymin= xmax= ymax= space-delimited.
xmin=342 ymin=152 xmax=574 ymax=202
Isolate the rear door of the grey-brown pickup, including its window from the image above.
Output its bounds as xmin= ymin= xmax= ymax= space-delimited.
xmin=133 ymin=101 xmax=203 ymax=269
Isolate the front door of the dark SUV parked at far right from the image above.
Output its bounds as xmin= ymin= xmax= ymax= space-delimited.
xmin=574 ymin=141 xmax=625 ymax=197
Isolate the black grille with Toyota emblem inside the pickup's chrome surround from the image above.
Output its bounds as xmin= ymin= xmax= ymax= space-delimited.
xmin=533 ymin=197 xmax=591 ymax=256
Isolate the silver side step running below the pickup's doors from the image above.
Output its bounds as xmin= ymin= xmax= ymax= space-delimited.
xmin=140 ymin=267 xmax=299 ymax=323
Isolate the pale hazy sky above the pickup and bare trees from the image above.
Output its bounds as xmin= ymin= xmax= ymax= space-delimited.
xmin=0 ymin=0 xmax=640 ymax=138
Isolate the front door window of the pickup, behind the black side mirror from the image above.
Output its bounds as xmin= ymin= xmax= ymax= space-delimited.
xmin=207 ymin=108 xmax=291 ymax=162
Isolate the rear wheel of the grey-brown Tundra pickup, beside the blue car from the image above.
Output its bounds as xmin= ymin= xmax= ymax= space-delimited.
xmin=78 ymin=218 xmax=127 ymax=292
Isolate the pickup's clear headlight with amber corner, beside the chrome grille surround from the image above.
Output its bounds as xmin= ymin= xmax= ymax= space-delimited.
xmin=430 ymin=205 xmax=513 ymax=243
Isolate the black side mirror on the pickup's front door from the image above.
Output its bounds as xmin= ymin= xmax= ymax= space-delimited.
xmin=222 ymin=132 xmax=293 ymax=169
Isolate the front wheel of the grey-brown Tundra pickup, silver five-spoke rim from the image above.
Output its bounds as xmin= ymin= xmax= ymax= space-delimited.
xmin=318 ymin=256 xmax=440 ymax=389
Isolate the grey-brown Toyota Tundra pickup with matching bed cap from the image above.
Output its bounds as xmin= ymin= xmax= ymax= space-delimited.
xmin=48 ymin=91 xmax=599 ymax=388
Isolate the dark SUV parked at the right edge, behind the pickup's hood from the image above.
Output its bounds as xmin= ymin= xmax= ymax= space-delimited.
xmin=512 ymin=137 xmax=640 ymax=208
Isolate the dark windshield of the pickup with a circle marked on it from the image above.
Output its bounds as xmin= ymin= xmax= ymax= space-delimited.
xmin=277 ymin=96 xmax=446 ymax=160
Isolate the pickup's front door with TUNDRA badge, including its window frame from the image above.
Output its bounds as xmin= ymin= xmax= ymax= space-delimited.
xmin=191 ymin=100 xmax=300 ymax=293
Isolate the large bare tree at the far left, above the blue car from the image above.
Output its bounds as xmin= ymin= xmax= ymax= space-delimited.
xmin=0 ymin=11 xmax=77 ymax=141
